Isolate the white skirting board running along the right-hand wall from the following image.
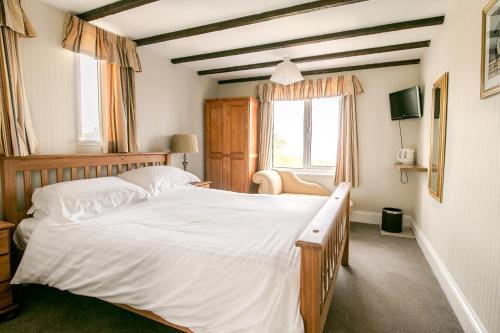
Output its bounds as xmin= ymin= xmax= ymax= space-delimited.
xmin=412 ymin=223 xmax=488 ymax=333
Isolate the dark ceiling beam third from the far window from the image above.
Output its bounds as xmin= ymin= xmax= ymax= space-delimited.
xmin=171 ymin=16 xmax=444 ymax=64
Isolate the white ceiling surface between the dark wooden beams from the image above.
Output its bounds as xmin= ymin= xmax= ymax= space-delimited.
xmin=43 ymin=0 xmax=451 ymax=80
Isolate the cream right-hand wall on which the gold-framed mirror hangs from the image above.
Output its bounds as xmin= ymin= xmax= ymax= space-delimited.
xmin=416 ymin=0 xmax=500 ymax=333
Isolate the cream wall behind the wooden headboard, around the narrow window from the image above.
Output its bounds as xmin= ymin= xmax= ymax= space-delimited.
xmin=20 ymin=0 xmax=217 ymax=177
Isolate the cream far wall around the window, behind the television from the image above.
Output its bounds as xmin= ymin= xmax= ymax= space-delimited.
xmin=218 ymin=65 xmax=421 ymax=214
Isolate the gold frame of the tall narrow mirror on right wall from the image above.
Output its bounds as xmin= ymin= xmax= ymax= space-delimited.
xmin=428 ymin=73 xmax=448 ymax=202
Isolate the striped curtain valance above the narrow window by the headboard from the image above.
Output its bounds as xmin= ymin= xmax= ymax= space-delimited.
xmin=63 ymin=16 xmax=142 ymax=72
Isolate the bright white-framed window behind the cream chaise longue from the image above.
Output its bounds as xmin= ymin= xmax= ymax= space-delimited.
xmin=272 ymin=97 xmax=340 ymax=171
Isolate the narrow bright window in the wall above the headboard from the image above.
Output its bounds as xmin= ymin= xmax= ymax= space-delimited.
xmin=78 ymin=54 xmax=101 ymax=144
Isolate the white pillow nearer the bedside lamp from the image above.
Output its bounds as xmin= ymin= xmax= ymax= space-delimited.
xmin=118 ymin=165 xmax=200 ymax=195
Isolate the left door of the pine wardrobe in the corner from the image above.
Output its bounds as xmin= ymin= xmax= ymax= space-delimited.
xmin=205 ymin=101 xmax=224 ymax=189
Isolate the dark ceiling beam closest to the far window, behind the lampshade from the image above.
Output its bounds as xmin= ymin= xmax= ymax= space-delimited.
xmin=219 ymin=59 xmax=420 ymax=84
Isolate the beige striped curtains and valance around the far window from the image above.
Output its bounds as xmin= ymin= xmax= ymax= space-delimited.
xmin=258 ymin=75 xmax=363 ymax=187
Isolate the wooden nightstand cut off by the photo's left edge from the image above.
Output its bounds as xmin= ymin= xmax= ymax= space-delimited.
xmin=0 ymin=221 xmax=17 ymax=319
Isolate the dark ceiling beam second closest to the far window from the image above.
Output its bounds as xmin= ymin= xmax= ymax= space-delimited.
xmin=198 ymin=40 xmax=431 ymax=75
